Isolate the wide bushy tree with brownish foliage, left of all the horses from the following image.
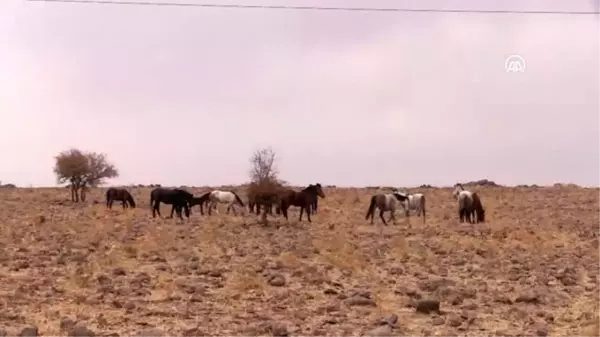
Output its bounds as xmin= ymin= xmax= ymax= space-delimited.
xmin=54 ymin=148 xmax=119 ymax=202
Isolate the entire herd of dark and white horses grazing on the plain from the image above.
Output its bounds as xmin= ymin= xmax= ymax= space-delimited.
xmin=106 ymin=183 xmax=485 ymax=225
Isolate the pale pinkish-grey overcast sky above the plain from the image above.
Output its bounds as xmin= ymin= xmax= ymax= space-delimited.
xmin=0 ymin=0 xmax=600 ymax=186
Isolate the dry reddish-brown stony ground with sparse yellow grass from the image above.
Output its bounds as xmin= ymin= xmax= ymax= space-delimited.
xmin=0 ymin=187 xmax=600 ymax=337
